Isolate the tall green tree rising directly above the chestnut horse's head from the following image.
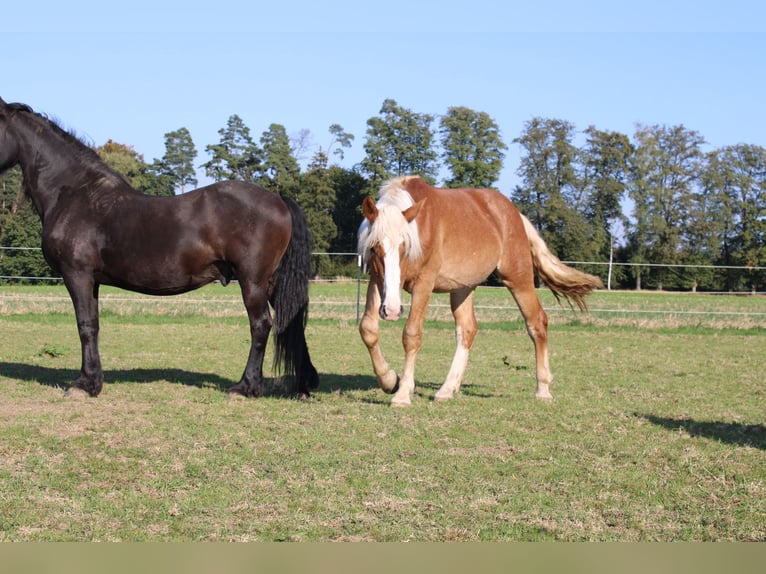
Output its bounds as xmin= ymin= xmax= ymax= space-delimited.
xmin=361 ymin=99 xmax=439 ymax=191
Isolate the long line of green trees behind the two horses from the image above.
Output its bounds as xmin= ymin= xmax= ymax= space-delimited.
xmin=0 ymin=99 xmax=766 ymax=291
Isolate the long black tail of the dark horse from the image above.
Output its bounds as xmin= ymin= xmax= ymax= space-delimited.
xmin=271 ymin=197 xmax=319 ymax=395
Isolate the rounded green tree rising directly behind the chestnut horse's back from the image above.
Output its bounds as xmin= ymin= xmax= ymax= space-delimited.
xmin=439 ymin=107 xmax=508 ymax=188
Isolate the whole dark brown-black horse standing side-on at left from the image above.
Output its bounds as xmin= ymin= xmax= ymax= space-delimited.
xmin=0 ymin=99 xmax=319 ymax=397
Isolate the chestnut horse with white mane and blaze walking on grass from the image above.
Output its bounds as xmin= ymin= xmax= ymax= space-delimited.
xmin=358 ymin=176 xmax=603 ymax=406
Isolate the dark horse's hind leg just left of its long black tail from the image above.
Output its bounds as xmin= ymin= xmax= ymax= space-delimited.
xmin=228 ymin=278 xmax=271 ymax=397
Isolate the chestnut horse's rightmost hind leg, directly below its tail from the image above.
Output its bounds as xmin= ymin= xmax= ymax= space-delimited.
xmin=502 ymin=276 xmax=553 ymax=400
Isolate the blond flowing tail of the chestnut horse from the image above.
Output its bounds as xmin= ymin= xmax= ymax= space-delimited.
xmin=520 ymin=213 xmax=604 ymax=311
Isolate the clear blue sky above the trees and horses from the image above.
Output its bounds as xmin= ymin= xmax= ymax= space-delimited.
xmin=0 ymin=0 xmax=766 ymax=194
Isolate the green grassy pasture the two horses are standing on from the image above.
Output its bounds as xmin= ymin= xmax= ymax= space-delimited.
xmin=0 ymin=284 xmax=766 ymax=541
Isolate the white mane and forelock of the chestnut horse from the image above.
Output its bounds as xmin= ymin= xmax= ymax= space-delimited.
xmin=357 ymin=176 xmax=423 ymax=264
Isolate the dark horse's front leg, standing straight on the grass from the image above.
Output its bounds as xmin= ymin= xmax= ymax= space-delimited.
xmin=64 ymin=273 xmax=104 ymax=397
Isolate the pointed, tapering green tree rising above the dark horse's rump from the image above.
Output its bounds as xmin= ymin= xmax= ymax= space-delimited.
xmin=202 ymin=114 xmax=262 ymax=181
